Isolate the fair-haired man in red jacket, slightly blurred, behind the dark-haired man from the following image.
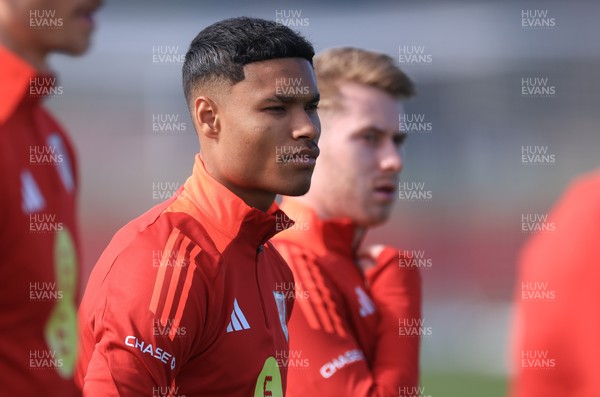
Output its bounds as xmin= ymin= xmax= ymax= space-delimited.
xmin=275 ymin=48 xmax=421 ymax=397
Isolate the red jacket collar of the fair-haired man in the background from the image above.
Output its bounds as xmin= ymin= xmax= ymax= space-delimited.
xmin=277 ymin=197 xmax=360 ymax=260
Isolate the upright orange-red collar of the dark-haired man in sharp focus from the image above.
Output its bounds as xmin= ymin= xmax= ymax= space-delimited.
xmin=167 ymin=155 xmax=293 ymax=252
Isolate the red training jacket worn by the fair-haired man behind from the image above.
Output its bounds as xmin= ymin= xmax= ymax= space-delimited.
xmin=274 ymin=198 xmax=421 ymax=397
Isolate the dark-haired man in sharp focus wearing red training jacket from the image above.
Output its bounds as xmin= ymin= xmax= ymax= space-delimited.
xmin=76 ymin=18 xmax=320 ymax=397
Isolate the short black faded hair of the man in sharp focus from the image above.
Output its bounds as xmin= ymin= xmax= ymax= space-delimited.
xmin=182 ymin=17 xmax=315 ymax=104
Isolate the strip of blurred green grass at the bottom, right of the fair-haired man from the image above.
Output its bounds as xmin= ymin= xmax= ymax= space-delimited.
xmin=421 ymin=371 xmax=507 ymax=397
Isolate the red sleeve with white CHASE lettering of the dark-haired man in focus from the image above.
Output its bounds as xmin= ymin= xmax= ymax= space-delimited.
xmin=78 ymin=234 xmax=206 ymax=397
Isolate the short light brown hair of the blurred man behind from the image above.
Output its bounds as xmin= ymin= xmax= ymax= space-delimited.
xmin=314 ymin=47 xmax=415 ymax=108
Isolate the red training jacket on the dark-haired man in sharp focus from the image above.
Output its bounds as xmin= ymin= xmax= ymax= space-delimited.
xmin=76 ymin=155 xmax=293 ymax=397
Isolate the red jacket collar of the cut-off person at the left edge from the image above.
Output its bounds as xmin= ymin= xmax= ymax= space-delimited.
xmin=0 ymin=46 xmax=54 ymax=124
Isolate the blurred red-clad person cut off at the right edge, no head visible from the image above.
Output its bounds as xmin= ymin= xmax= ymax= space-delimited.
xmin=511 ymin=171 xmax=600 ymax=397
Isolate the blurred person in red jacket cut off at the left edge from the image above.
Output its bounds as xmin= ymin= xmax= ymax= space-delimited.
xmin=0 ymin=0 xmax=100 ymax=397
